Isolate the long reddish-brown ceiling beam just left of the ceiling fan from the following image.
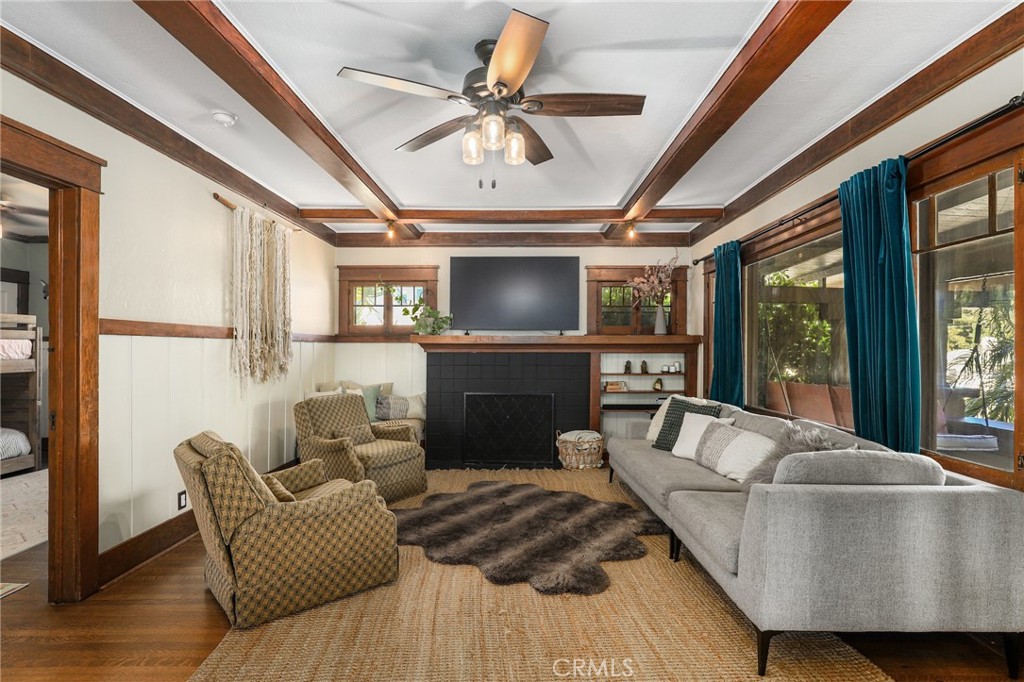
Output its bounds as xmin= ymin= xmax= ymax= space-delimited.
xmin=135 ymin=0 xmax=398 ymax=220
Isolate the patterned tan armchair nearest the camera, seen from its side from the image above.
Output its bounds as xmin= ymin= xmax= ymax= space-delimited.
xmin=174 ymin=431 xmax=398 ymax=628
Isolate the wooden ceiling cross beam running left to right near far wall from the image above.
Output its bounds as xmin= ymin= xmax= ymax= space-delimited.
xmin=299 ymin=206 xmax=725 ymax=224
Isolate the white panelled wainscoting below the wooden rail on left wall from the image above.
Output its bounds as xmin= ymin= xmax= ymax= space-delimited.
xmin=99 ymin=336 xmax=335 ymax=552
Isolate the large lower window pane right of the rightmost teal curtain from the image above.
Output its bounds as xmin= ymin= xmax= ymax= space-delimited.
xmin=920 ymin=232 xmax=1015 ymax=471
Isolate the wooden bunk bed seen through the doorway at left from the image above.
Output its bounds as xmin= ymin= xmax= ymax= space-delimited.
xmin=0 ymin=312 xmax=45 ymax=474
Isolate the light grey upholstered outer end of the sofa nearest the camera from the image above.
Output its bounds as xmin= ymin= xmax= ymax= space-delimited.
xmin=737 ymin=484 xmax=1024 ymax=632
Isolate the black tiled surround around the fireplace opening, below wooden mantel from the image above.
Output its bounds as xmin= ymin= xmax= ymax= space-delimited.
xmin=425 ymin=352 xmax=590 ymax=469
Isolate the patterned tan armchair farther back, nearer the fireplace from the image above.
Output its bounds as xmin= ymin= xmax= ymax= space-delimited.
xmin=295 ymin=394 xmax=427 ymax=502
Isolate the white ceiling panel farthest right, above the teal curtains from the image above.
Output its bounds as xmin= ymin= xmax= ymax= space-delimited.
xmin=660 ymin=1 xmax=1021 ymax=206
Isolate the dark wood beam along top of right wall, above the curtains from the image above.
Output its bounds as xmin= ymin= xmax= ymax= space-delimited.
xmin=693 ymin=5 xmax=1024 ymax=244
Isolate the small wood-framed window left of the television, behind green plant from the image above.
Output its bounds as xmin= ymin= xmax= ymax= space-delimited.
xmin=338 ymin=265 xmax=437 ymax=341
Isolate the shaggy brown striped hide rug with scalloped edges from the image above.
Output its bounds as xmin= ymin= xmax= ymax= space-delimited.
xmin=393 ymin=480 xmax=667 ymax=594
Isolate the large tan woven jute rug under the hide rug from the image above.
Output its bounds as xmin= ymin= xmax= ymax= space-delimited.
xmin=191 ymin=469 xmax=890 ymax=682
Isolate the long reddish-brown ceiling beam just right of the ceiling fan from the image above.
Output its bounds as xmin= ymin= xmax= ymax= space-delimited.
xmin=625 ymin=0 xmax=850 ymax=219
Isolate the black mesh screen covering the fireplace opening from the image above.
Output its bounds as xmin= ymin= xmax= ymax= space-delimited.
xmin=462 ymin=393 xmax=555 ymax=467
